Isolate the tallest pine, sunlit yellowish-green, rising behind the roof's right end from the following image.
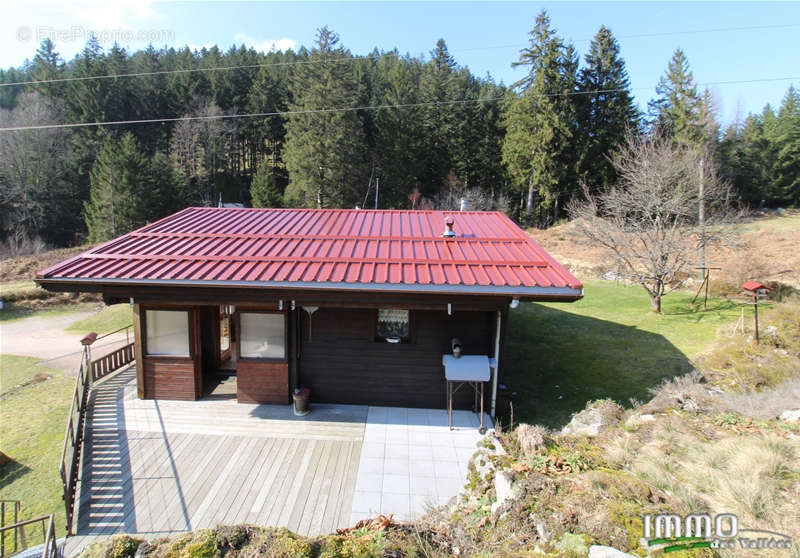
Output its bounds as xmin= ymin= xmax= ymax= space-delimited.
xmin=503 ymin=10 xmax=578 ymax=225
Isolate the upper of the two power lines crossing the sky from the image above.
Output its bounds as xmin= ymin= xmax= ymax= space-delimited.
xmin=0 ymin=23 xmax=800 ymax=87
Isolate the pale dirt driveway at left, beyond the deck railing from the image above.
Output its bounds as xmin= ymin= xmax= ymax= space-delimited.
xmin=0 ymin=312 xmax=125 ymax=374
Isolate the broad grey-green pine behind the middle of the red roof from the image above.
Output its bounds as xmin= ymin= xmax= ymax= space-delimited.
xmin=283 ymin=27 xmax=369 ymax=207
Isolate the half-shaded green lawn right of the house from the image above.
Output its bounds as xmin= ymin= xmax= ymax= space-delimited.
xmin=500 ymin=281 xmax=752 ymax=427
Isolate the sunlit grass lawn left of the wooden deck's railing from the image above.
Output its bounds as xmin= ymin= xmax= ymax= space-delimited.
xmin=0 ymin=355 xmax=75 ymax=544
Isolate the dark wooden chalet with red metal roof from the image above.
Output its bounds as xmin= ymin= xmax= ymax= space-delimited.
xmin=36 ymin=207 xmax=583 ymax=415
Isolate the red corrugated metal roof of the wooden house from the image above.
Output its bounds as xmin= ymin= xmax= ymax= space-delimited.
xmin=37 ymin=207 xmax=582 ymax=298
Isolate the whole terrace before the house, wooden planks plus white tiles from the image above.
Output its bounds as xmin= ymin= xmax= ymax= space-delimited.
xmin=62 ymin=367 xmax=490 ymax=555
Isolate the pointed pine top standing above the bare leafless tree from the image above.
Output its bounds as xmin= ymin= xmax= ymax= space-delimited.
xmin=649 ymin=48 xmax=704 ymax=145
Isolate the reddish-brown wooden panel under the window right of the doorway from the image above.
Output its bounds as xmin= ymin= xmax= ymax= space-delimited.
xmin=236 ymin=359 xmax=289 ymax=405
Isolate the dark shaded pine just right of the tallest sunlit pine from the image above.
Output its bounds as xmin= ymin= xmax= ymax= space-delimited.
xmin=577 ymin=26 xmax=640 ymax=189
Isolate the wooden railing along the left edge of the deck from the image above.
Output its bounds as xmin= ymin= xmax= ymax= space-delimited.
xmin=58 ymin=326 xmax=136 ymax=535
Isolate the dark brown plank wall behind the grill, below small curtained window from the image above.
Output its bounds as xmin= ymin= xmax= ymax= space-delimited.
xmin=299 ymin=308 xmax=495 ymax=412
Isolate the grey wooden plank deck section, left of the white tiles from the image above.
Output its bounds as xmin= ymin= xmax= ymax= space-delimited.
xmin=67 ymin=369 xmax=367 ymax=555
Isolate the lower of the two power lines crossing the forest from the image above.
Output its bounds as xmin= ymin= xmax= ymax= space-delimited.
xmin=0 ymin=76 xmax=800 ymax=132
